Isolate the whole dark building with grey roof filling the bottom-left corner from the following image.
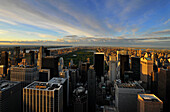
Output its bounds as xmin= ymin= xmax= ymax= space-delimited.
xmin=0 ymin=80 xmax=22 ymax=112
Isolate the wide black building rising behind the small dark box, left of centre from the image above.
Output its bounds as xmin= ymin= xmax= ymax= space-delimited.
xmin=42 ymin=56 xmax=59 ymax=79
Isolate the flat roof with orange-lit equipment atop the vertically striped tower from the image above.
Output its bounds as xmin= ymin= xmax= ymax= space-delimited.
xmin=25 ymin=81 xmax=62 ymax=91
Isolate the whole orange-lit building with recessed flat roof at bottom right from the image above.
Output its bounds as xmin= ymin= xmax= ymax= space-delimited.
xmin=137 ymin=94 xmax=163 ymax=112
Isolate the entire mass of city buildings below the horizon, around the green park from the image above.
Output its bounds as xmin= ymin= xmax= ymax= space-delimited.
xmin=0 ymin=46 xmax=170 ymax=112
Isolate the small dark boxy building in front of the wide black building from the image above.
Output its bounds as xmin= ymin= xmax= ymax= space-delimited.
xmin=39 ymin=69 xmax=50 ymax=82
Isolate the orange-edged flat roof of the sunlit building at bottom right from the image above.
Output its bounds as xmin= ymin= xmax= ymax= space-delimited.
xmin=138 ymin=94 xmax=162 ymax=102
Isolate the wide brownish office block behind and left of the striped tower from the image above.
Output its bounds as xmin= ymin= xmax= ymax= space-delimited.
xmin=10 ymin=66 xmax=39 ymax=87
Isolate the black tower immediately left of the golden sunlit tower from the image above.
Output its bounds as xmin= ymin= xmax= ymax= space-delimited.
xmin=131 ymin=57 xmax=140 ymax=81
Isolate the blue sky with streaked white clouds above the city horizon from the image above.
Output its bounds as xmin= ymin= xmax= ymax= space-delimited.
xmin=0 ymin=0 xmax=170 ymax=48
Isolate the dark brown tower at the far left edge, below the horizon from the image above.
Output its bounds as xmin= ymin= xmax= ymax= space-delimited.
xmin=1 ymin=51 xmax=8 ymax=74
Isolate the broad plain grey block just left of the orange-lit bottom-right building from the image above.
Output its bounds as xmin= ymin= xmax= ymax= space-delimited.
xmin=115 ymin=82 xmax=145 ymax=112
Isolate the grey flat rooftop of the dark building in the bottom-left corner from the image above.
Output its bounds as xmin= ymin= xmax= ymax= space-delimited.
xmin=0 ymin=80 xmax=19 ymax=91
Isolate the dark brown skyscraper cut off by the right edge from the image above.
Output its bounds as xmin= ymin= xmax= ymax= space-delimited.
xmin=158 ymin=67 xmax=170 ymax=112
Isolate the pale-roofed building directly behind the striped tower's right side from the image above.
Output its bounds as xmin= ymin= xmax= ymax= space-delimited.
xmin=48 ymin=77 xmax=69 ymax=112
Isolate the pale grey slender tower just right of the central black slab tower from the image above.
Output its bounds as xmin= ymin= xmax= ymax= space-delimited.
xmin=108 ymin=61 xmax=117 ymax=82
